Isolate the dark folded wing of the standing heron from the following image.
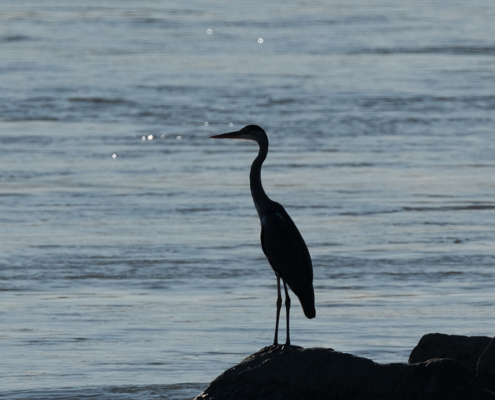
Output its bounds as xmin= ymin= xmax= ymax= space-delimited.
xmin=261 ymin=206 xmax=313 ymax=300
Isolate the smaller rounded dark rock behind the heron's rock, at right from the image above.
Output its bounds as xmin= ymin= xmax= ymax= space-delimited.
xmin=409 ymin=333 xmax=492 ymax=375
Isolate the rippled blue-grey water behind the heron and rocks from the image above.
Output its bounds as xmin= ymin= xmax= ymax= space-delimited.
xmin=0 ymin=0 xmax=495 ymax=399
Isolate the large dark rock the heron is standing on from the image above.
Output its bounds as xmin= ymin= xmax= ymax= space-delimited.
xmin=196 ymin=346 xmax=495 ymax=400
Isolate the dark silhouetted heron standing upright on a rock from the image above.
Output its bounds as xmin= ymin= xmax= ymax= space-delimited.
xmin=211 ymin=125 xmax=316 ymax=346
